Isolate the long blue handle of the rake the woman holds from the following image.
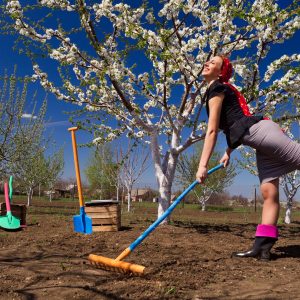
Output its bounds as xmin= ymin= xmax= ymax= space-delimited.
xmin=128 ymin=164 xmax=224 ymax=252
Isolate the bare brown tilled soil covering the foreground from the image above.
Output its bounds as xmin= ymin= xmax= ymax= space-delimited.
xmin=0 ymin=201 xmax=300 ymax=300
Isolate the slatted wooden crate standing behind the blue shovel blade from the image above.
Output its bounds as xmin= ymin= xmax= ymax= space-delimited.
xmin=85 ymin=200 xmax=121 ymax=232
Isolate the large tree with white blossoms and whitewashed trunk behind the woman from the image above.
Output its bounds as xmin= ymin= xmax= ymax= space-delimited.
xmin=6 ymin=0 xmax=300 ymax=220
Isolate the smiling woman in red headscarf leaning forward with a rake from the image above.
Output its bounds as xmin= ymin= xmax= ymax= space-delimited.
xmin=196 ymin=56 xmax=300 ymax=260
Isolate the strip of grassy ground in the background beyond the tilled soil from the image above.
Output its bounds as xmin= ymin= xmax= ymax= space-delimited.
xmin=7 ymin=196 xmax=300 ymax=226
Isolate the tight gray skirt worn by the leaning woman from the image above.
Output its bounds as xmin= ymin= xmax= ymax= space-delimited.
xmin=241 ymin=120 xmax=300 ymax=183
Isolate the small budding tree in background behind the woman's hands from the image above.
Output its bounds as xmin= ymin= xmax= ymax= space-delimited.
xmin=176 ymin=142 xmax=236 ymax=211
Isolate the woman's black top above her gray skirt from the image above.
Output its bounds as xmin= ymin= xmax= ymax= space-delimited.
xmin=204 ymin=80 xmax=263 ymax=149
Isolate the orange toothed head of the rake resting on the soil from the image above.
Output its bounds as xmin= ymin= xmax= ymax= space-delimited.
xmin=88 ymin=254 xmax=145 ymax=275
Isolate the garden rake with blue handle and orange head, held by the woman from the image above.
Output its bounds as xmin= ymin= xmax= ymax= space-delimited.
xmin=88 ymin=164 xmax=224 ymax=275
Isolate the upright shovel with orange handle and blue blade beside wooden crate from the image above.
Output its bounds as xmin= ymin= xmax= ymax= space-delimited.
xmin=68 ymin=127 xmax=92 ymax=234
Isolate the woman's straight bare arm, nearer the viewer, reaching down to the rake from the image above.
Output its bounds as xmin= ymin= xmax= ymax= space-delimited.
xmin=196 ymin=94 xmax=224 ymax=182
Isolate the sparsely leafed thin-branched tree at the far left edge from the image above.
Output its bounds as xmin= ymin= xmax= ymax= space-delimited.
xmin=0 ymin=72 xmax=47 ymax=178
